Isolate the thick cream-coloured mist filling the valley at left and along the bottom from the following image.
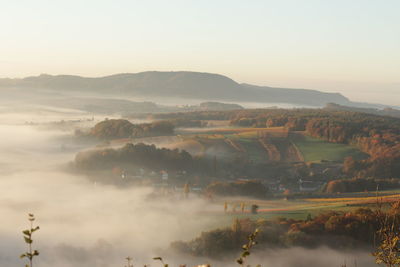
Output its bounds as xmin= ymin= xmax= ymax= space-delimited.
xmin=0 ymin=113 xmax=374 ymax=267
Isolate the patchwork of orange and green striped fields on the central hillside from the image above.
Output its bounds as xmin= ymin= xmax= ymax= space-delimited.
xmin=132 ymin=127 xmax=367 ymax=163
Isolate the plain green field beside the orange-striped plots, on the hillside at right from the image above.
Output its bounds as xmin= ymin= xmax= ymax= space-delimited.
xmin=293 ymin=136 xmax=368 ymax=161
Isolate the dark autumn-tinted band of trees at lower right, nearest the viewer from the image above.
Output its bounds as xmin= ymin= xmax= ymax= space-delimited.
xmin=171 ymin=205 xmax=390 ymax=258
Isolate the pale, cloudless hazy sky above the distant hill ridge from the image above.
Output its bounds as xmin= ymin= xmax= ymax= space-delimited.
xmin=0 ymin=0 xmax=400 ymax=105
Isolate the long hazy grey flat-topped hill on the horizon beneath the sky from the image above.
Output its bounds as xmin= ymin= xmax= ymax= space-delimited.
xmin=0 ymin=71 xmax=351 ymax=106
